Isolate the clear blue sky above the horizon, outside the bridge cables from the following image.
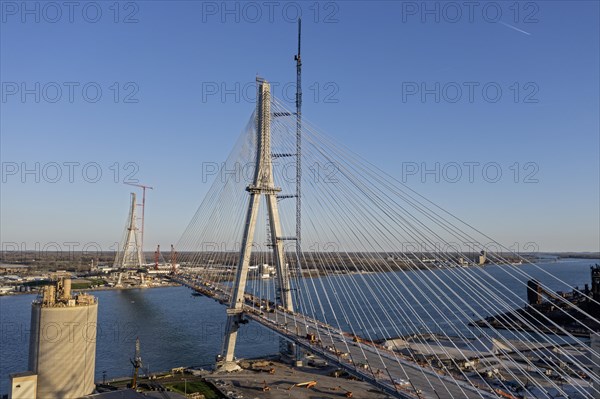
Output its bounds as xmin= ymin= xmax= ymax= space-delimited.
xmin=0 ymin=1 xmax=600 ymax=251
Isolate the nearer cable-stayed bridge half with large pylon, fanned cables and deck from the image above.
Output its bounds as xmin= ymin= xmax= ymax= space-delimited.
xmin=173 ymin=80 xmax=600 ymax=398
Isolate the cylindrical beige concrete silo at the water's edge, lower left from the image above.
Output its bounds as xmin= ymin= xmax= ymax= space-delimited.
xmin=29 ymin=279 xmax=98 ymax=399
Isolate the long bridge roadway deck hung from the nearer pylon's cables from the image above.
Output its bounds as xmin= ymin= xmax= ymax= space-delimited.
xmin=171 ymin=274 xmax=497 ymax=399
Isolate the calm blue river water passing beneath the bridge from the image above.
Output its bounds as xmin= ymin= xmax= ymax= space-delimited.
xmin=0 ymin=259 xmax=599 ymax=394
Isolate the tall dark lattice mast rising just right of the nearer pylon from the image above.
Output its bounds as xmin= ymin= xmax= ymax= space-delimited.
xmin=294 ymin=18 xmax=302 ymax=278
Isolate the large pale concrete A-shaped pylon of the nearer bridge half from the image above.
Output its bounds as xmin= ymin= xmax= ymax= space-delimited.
xmin=217 ymin=78 xmax=294 ymax=371
